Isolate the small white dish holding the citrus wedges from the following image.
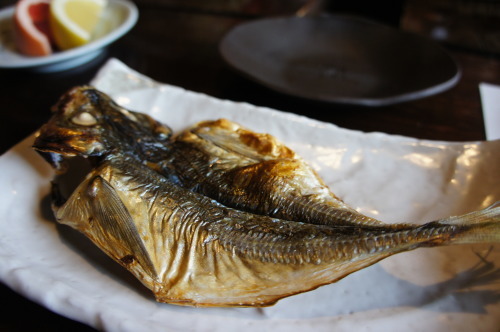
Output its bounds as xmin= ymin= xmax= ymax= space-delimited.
xmin=0 ymin=0 xmax=138 ymax=72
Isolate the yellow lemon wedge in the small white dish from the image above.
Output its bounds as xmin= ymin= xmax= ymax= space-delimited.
xmin=50 ymin=0 xmax=107 ymax=50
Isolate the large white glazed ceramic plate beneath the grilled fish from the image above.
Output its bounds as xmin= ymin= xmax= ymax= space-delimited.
xmin=0 ymin=60 xmax=500 ymax=332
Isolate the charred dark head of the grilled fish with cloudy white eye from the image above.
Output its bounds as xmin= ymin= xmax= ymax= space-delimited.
xmin=33 ymin=86 xmax=172 ymax=169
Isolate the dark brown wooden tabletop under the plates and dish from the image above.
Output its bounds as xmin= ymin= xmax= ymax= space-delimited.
xmin=0 ymin=0 xmax=500 ymax=331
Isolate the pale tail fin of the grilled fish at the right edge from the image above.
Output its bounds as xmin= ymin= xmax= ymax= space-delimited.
xmin=430 ymin=201 xmax=500 ymax=244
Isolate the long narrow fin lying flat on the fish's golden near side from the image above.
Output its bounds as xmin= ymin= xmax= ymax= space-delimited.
xmin=88 ymin=176 xmax=157 ymax=278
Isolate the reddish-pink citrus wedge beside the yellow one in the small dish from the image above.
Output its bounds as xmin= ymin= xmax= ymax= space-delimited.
xmin=14 ymin=0 xmax=52 ymax=56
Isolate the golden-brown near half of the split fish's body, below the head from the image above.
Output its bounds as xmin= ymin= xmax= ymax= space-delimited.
xmin=50 ymin=157 xmax=499 ymax=306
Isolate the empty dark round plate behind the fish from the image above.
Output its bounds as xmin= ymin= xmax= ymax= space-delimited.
xmin=220 ymin=15 xmax=460 ymax=106
